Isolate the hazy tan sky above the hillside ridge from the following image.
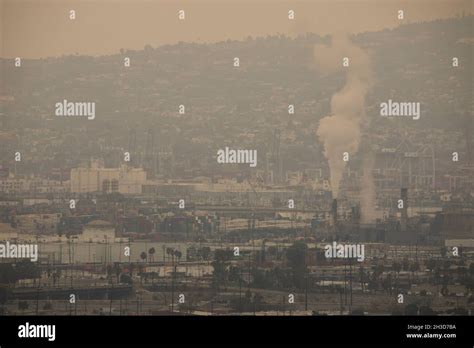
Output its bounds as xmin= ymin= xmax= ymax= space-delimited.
xmin=0 ymin=0 xmax=473 ymax=58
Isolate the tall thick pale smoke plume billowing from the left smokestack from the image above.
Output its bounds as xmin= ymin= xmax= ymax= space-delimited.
xmin=314 ymin=36 xmax=372 ymax=198
